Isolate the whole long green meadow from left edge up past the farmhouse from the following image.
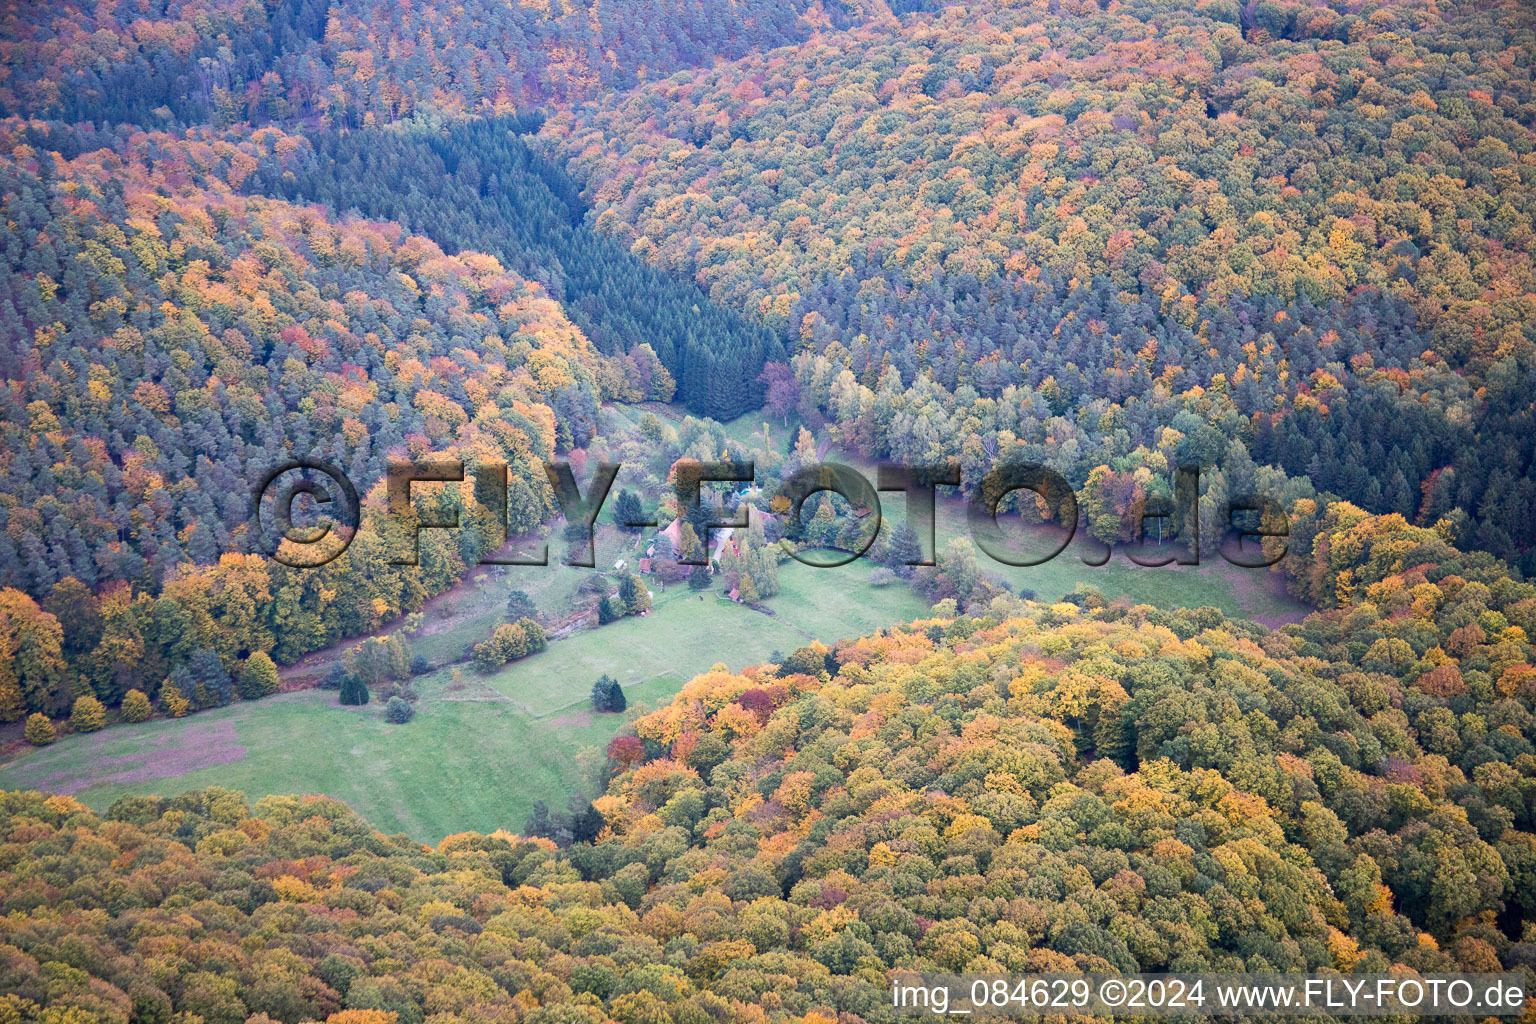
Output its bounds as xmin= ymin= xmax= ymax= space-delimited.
xmin=0 ymin=563 xmax=926 ymax=841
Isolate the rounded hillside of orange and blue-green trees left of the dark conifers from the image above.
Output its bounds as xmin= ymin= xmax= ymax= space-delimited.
xmin=0 ymin=123 xmax=617 ymax=720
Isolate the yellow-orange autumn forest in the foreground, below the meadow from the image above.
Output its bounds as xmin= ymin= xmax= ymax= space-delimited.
xmin=0 ymin=515 xmax=1536 ymax=1024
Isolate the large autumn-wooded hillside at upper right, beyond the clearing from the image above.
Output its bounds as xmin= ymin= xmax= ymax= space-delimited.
xmin=541 ymin=0 xmax=1536 ymax=568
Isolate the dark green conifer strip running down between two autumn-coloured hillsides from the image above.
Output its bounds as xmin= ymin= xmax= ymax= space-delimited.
xmin=243 ymin=118 xmax=785 ymax=419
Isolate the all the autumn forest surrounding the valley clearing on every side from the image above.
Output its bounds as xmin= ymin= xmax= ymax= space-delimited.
xmin=0 ymin=0 xmax=1536 ymax=1024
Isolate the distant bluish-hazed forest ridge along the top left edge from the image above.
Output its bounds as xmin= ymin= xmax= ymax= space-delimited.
xmin=0 ymin=0 xmax=848 ymax=127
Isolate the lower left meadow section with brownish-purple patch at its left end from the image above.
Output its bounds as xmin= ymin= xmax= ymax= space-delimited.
xmin=0 ymin=674 xmax=616 ymax=841
